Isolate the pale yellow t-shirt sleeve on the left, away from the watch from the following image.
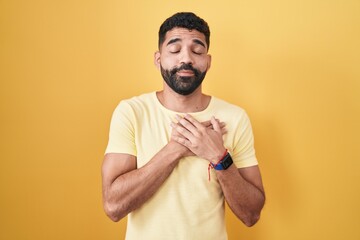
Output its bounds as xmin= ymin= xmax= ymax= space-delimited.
xmin=105 ymin=101 xmax=137 ymax=156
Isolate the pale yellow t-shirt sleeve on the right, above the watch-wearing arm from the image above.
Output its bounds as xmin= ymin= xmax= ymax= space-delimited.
xmin=231 ymin=111 xmax=258 ymax=168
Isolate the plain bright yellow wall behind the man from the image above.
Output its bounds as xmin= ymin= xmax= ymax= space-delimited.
xmin=0 ymin=0 xmax=360 ymax=240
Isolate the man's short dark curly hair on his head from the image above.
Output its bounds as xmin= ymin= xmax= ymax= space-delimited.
xmin=159 ymin=12 xmax=210 ymax=50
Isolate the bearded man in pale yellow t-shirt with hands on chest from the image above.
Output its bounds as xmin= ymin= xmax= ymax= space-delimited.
xmin=102 ymin=13 xmax=265 ymax=240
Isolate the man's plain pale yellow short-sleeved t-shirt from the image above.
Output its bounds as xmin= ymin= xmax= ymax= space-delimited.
xmin=106 ymin=92 xmax=257 ymax=240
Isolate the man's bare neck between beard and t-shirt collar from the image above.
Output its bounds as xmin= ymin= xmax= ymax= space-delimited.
xmin=156 ymin=86 xmax=211 ymax=113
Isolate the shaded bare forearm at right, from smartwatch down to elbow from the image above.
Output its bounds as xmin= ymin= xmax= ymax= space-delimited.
xmin=216 ymin=164 xmax=265 ymax=227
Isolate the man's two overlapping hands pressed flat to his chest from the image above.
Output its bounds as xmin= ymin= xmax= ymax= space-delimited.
xmin=171 ymin=114 xmax=226 ymax=163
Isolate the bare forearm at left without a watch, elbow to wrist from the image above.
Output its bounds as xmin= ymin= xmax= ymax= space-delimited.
xmin=105 ymin=142 xmax=181 ymax=221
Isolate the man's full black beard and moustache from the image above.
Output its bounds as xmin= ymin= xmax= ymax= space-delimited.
xmin=160 ymin=64 xmax=206 ymax=96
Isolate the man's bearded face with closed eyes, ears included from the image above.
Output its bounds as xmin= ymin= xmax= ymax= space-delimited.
xmin=155 ymin=28 xmax=211 ymax=95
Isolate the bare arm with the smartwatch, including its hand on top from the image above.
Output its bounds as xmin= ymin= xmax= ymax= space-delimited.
xmin=173 ymin=115 xmax=265 ymax=226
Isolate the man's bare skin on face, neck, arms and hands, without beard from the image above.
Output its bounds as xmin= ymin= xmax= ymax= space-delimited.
xmin=102 ymin=28 xmax=265 ymax=226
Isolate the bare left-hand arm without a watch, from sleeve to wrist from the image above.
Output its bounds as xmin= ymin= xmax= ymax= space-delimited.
xmin=102 ymin=141 xmax=188 ymax=221
